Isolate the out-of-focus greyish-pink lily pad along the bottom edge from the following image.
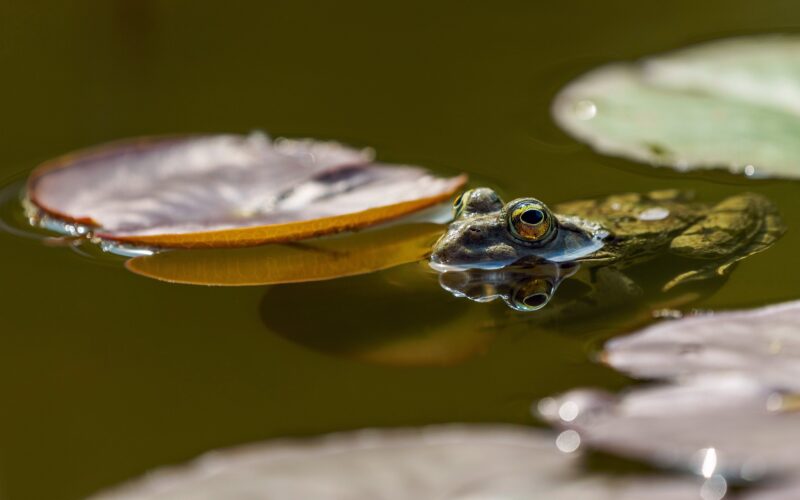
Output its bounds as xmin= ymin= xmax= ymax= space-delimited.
xmin=92 ymin=426 xmax=700 ymax=500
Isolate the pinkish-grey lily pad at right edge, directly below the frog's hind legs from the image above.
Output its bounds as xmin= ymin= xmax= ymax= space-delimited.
xmin=603 ymin=302 xmax=800 ymax=392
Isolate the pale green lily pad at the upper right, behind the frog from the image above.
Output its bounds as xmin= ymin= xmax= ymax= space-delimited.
xmin=553 ymin=35 xmax=800 ymax=178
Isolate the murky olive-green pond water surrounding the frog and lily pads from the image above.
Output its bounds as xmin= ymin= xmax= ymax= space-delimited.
xmin=0 ymin=0 xmax=800 ymax=500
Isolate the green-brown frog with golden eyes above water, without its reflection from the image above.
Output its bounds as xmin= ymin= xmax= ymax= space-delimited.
xmin=431 ymin=188 xmax=785 ymax=296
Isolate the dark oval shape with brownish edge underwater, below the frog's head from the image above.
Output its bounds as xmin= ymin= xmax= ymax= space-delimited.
xmin=261 ymin=264 xmax=495 ymax=366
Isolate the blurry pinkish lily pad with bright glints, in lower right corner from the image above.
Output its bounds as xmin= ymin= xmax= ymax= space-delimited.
xmin=539 ymin=375 xmax=800 ymax=480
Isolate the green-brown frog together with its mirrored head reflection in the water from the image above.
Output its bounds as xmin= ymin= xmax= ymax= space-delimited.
xmin=430 ymin=188 xmax=785 ymax=311
